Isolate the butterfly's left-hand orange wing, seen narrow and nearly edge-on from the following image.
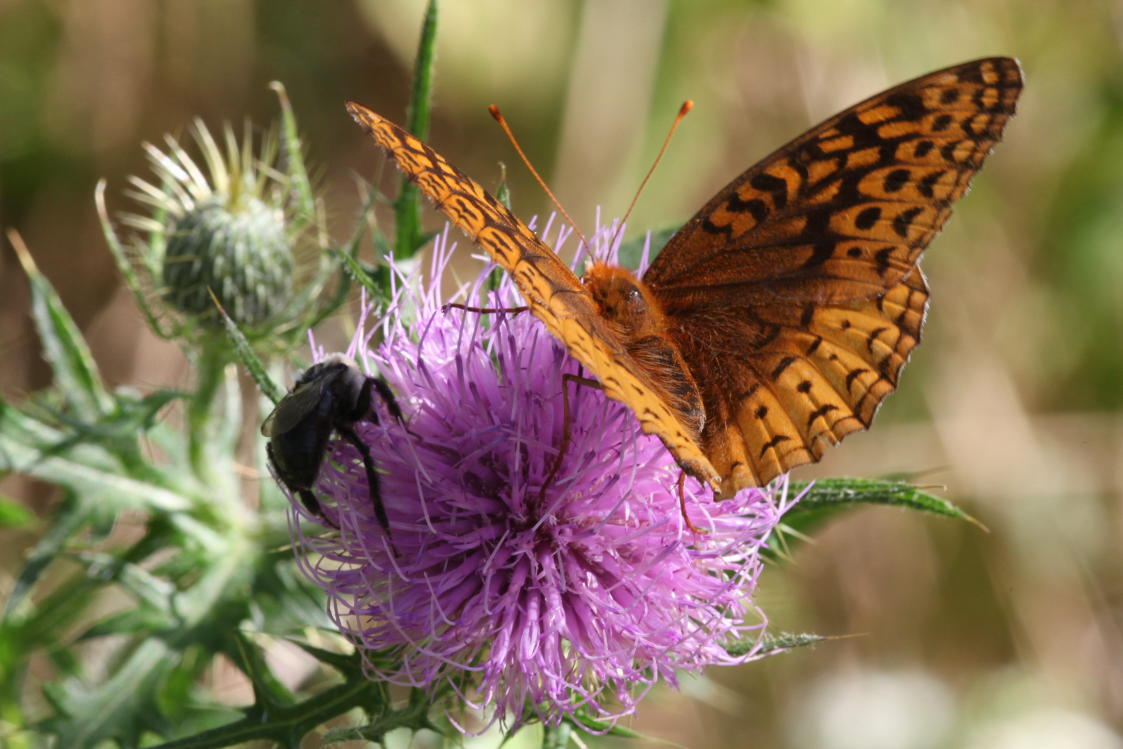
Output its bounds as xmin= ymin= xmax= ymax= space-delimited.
xmin=347 ymin=102 xmax=719 ymax=487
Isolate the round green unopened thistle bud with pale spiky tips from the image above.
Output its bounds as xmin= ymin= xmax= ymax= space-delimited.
xmin=99 ymin=106 xmax=310 ymax=340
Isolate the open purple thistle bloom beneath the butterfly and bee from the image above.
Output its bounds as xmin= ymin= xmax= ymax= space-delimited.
xmin=293 ymin=217 xmax=787 ymax=724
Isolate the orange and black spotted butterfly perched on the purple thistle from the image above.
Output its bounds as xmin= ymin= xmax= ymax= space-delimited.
xmin=347 ymin=57 xmax=1022 ymax=496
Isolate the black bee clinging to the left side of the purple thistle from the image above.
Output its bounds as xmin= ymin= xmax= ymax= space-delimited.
xmin=262 ymin=354 xmax=402 ymax=537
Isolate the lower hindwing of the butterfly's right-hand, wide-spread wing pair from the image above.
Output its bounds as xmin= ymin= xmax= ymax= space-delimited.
xmin=682 ymin=268 xmax=928 ymax=494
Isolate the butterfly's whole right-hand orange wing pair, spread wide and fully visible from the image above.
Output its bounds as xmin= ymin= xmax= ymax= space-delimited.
xmin=643 ymin=57 xmax=1022 ymax=495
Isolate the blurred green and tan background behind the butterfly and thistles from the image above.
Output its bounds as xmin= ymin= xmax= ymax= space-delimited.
xmin=0 ymin=0 xmax=1123 ymax=749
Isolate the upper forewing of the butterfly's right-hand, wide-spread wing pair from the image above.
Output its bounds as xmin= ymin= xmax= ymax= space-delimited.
xmin=643 ymin=57 xmax=1022 ymax=309
